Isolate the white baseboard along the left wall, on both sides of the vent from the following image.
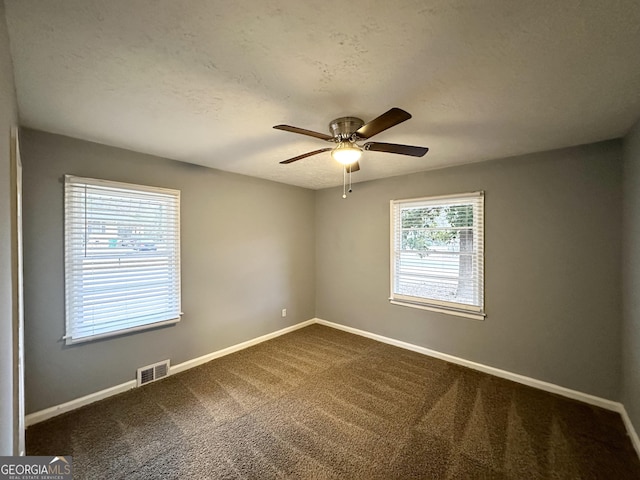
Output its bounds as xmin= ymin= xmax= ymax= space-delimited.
xmin=24 ymin=319 xmax=316 ymax=427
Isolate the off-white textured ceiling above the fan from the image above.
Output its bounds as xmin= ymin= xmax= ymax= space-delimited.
xmin=5 ymin=0 xmax=640 ymax=189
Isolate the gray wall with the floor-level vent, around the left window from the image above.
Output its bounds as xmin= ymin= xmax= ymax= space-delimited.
xmin=21 ymin=130 xmax=315 ymax=413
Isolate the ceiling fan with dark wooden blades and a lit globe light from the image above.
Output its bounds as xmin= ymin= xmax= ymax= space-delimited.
xmin=273 ymin=107 xmax=429 ymax=173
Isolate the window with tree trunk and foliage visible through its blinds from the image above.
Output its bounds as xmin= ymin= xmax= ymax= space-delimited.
xmin=390 ymin=192 xmax=484 ymax=319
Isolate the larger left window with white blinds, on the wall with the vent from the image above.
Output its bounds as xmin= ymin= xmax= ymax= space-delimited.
xmin=64 ymin=175 xmax=180 ymax=344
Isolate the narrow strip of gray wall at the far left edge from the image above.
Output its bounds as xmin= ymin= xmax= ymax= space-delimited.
xmin=0 ymin=0 xmax=18 ymax=455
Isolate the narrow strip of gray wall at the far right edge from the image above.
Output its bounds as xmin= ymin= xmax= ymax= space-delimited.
xmin=622 ymin=121 xmax=640 ymax=432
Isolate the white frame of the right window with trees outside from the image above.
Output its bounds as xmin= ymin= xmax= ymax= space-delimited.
xmin=389 ymin=191 xmax=486 ymax=320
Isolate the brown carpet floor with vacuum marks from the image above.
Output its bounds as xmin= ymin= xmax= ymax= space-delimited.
xmin=27 ymin=325 xmax=640 ymax=480
